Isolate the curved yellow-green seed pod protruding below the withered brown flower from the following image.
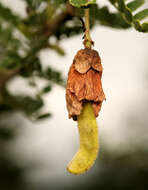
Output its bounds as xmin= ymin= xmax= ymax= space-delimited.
xmin=67 ymin=103 xmax=99 ymax=174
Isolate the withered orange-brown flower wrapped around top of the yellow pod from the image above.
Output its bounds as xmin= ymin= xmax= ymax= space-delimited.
xmin=66 ymin=48 xmax=105 ymax=120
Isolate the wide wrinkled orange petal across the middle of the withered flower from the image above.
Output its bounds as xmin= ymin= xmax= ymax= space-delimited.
xmin=67 ymin=65 xmax=104 ymax=101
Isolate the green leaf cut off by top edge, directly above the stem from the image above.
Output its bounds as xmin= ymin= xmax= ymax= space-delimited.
xmin=69 ymin=0 xmax=96 ymax=8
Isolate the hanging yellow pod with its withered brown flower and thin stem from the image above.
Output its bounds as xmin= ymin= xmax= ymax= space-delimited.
xmin=66 ymin=1 xmax=105 ymax=174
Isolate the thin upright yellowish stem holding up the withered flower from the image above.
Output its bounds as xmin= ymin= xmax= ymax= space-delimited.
xmin=84 ymin=8 xmax=92 ymax=48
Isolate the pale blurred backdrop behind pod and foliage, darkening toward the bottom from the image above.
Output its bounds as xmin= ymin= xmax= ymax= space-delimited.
xmin=0 ymin=0 xmax=148 ymax=190
